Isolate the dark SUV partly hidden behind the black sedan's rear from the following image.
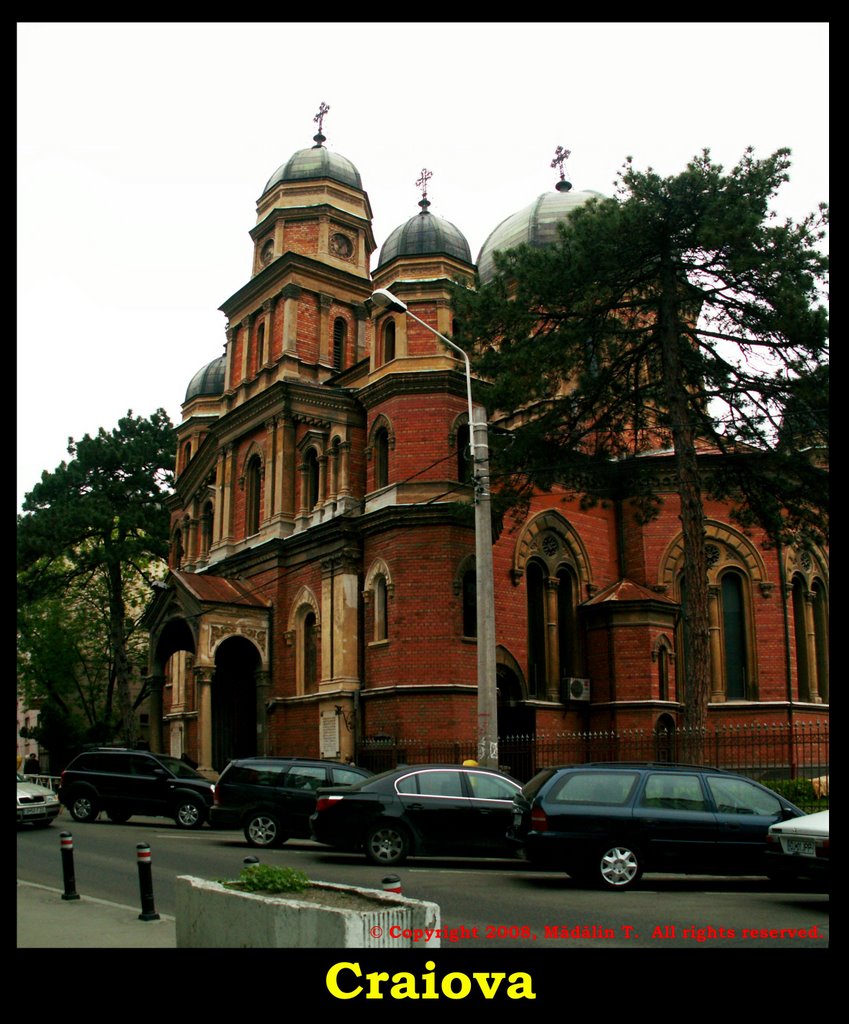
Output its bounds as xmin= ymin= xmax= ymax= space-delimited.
xmin=210 ymin=757 xmax=372 ymax=847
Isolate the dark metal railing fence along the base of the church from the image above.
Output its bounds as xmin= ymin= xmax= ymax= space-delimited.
xmin=357 ymin=721 xmax=829 ymax=782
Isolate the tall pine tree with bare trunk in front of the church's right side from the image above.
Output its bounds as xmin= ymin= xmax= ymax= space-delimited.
xmin=455 ymin=150 xmax=829 ymax=745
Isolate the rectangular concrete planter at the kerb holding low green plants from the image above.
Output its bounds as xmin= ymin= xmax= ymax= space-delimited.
xmin=176 ymin=874 xmax=440 ymax=950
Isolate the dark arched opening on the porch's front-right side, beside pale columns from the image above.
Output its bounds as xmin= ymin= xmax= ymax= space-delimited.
xmin=212 ymin=637 xmax=260 ymax=771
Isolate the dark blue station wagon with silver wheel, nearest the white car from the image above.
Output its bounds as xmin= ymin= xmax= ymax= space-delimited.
xmin=508 ymin=763 xmax=803 ymax=890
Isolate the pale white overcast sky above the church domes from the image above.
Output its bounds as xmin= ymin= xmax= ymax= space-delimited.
xmin=16 ymin=23 xmax=829 ymax=516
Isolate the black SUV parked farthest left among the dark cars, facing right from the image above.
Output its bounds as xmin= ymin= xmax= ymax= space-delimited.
xmin=58 ymin=746 xmax=214 ymax=828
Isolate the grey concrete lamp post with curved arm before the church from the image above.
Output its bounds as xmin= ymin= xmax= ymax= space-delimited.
xmin=372 ymin=288 xmax=498 ymax=768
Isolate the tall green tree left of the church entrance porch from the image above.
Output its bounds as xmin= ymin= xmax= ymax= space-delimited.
xmin=17 ymin=410 xmax=175 ymax=745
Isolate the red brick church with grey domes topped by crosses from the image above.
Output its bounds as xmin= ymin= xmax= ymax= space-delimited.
xmin=144 ymin=113 xmax=829 ymax=771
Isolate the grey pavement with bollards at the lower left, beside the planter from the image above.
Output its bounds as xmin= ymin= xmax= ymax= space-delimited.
xmin=17 ymin=881 xmax=177 ymax=949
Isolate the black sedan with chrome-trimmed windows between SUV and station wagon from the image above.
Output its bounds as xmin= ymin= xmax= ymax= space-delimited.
xmin=309 ymin=765 xmax=521 ymax=867
